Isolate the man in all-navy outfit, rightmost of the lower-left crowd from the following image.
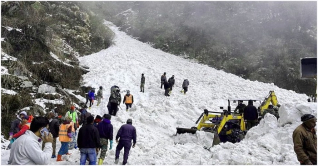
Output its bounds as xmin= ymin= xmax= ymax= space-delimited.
xmin=115 ymin=119 xmax=137 ymax=165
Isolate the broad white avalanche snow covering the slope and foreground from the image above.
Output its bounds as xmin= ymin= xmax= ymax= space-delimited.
xmin=1 ymin=22 xmax=317 ymax=165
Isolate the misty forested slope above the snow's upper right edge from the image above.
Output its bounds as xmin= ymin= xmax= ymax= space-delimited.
xmin=82 ymin=1 xmax=317 ymax=95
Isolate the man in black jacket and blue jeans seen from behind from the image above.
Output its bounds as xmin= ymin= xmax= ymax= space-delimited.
xmin=77 ymin=116 xmax=101 ymax=165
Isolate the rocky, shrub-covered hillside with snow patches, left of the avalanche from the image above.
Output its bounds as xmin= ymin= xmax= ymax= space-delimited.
xmin=1 ymin=1 xmax=113 ymax=137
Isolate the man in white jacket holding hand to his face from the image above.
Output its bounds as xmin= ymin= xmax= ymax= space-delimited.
xmin=8 ymin=117 xmax=53 ymax=165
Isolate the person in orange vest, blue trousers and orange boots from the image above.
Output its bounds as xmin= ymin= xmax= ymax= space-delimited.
xmin=56 ymin=116 xmax=75 ymax=161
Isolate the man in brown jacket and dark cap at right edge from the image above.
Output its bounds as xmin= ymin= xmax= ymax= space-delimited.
xmin=293 ymin=114 xmax=317 ymax=165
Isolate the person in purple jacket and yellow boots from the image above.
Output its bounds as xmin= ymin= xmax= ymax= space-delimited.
xmin=97 ymin=114 xmax=113 ymax=165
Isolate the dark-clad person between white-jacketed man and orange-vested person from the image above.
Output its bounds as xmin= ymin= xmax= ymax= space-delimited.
xmin=46 ymin=112 xmax=60 ymax=158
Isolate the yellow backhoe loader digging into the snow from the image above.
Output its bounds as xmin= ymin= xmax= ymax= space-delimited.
xmin=177 ymin=91 xmax=280 ymax=146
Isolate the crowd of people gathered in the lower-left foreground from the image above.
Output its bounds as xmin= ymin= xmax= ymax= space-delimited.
xmin=8 ymin=106 xmax=137 ymax=165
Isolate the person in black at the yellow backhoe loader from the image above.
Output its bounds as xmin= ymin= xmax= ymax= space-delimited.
xmin=244 ymin=100 xmax=258 ymax=130
